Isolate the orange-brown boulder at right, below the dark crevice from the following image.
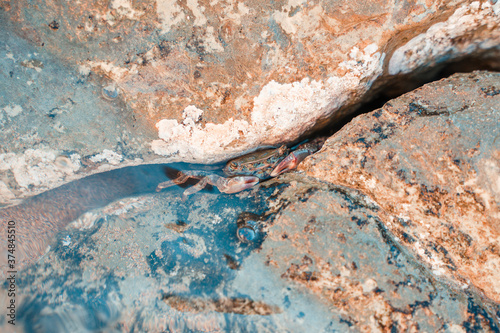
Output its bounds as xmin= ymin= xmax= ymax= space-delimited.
xmin=299 ymin=72 xmax=500 ymax=303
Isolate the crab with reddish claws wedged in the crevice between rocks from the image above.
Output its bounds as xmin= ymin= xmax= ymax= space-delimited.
xmin=156 ymin=138 xmax=325 ymax=200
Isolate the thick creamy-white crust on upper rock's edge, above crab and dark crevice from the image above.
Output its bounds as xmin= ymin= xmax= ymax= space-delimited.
xmin=151 ymin=1 xmax=500 ymax=163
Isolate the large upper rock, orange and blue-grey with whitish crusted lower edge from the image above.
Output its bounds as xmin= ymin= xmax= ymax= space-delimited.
xmin=0 ymin=0 xmax=500 ymax=203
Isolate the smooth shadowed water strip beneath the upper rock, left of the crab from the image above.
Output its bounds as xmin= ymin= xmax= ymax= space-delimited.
xmin=0 ymin=163 xmax=225 ymax=271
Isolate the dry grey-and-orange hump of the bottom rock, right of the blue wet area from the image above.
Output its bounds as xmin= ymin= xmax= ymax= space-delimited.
xmin=260 ymin=183 xmax=486 ymax=332
